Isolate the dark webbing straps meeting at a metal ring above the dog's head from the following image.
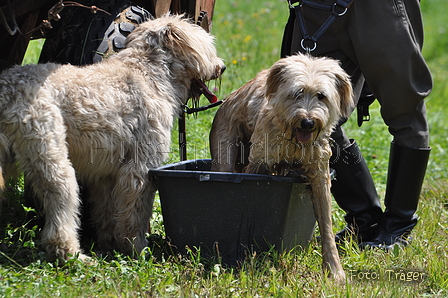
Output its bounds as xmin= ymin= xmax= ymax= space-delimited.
xmin=289 ymin=0 xmax=353 ymax=53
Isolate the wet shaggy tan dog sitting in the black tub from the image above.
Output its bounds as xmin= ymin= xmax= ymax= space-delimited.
xmin=210 ymin=54 xmax=353 ymax=279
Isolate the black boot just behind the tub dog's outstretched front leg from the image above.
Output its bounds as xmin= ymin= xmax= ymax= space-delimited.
xmin=330 ymin=140 xmax=382 ymax=243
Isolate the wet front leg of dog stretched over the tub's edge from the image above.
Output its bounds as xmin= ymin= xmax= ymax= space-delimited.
xmin=310 ymin=164 xmax=345 ymax=283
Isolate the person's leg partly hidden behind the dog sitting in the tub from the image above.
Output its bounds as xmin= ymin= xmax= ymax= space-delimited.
xmin=282 ymin=2 xmax=382 ymax=242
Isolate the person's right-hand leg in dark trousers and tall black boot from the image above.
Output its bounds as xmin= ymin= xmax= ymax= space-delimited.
xmin=349 ymin=0 xmax=432 ymax=247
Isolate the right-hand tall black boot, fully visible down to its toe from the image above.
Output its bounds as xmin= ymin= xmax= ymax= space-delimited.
xmin=361 ymin=142 xmax=431 ymax=249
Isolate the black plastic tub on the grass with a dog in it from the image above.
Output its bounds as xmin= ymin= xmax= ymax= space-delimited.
xmin=149 ymin=159 xmax=316 ymax=264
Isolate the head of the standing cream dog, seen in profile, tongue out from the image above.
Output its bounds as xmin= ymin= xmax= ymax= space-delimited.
xmin=126 ymin=15 xmax=225 ymax=99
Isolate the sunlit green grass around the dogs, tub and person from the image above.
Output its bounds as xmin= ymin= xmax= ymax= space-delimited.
xmin=0 ymin=0 xmax=448 ymax=297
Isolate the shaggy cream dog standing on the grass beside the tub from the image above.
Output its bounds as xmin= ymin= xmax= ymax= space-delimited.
xmin=0 ymin=16 xmax=224 ymax=259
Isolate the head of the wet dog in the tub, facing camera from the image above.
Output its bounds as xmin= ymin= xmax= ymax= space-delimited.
xmin=266 ymin=54 xmax=353 ymax=144
